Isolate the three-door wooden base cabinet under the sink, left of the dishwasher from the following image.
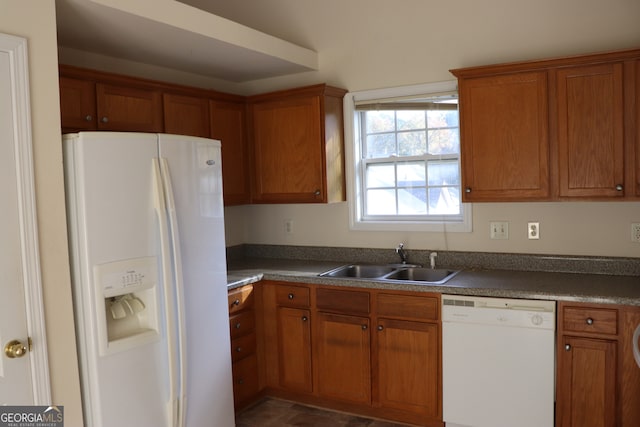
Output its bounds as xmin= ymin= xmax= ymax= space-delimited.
xmin=263 ymin=281 xmax=444 ymax=427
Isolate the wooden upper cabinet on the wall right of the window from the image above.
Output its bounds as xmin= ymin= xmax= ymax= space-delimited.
xmin=451 ymin=49 xmax=640 ymax=202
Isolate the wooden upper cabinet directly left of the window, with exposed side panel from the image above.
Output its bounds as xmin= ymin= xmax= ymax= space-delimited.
xmin=249 ymin=85 xmax=346 ymax=203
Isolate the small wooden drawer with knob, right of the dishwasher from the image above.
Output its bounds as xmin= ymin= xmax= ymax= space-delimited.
xmin=562 ymin=307 xmax=618 ymax=335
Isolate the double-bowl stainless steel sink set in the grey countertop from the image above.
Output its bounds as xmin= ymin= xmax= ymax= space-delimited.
xmin=319 ymin=264 xmax=458 ymax=285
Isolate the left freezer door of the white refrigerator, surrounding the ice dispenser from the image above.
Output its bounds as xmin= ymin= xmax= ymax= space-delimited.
xmin=64 ymin=132 xmax=168 ymax=427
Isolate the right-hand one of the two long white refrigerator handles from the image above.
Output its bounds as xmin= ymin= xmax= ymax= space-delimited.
xmin=160 ymin=157 xmax=187 ymax=427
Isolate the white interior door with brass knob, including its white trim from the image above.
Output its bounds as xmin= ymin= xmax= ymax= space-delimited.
xmin=0 ymin=34 xmax=50 ymax=405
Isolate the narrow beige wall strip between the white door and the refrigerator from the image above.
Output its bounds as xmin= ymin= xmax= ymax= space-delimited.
xmin=0 ymin=0 xmax=83 ymax=427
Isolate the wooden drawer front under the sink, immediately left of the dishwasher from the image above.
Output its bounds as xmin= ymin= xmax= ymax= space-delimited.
xmin=377 ymin=294 xmax=439 ymax=320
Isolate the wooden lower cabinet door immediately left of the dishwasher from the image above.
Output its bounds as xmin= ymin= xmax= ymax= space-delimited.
xmin=374 ymin=319 xmax=442 ymax=419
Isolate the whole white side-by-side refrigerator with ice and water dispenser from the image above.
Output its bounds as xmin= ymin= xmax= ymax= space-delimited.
xmin=63 ymin=132 xmax=235 ymax=427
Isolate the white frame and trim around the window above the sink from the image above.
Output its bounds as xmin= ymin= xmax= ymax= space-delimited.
xmin=344 ymin=80 xmax=473 ymax=232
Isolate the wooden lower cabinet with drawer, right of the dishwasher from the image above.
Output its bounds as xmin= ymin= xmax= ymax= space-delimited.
xmin=556 ymin=302 xmax=640 ymax=427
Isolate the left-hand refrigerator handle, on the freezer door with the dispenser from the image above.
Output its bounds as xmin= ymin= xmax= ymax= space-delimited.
xmin=153 ymin=158 xmax=184 ymax=427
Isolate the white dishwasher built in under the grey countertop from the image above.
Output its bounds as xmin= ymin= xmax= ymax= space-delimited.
xmin=442 ymin=295 xmax=556 ymax=427
